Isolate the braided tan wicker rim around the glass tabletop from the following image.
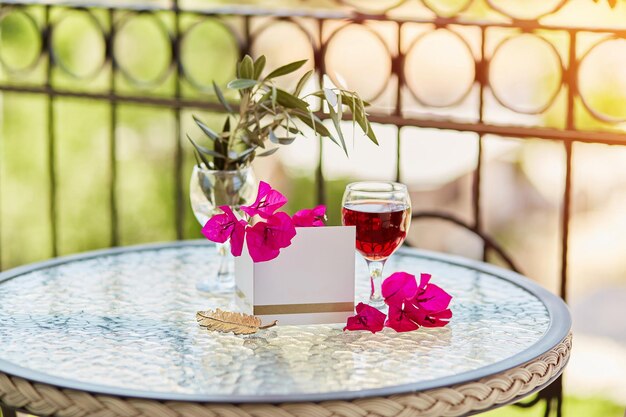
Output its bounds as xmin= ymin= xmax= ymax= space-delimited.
xmin=0 ymin=333 xmax=572 ymax=417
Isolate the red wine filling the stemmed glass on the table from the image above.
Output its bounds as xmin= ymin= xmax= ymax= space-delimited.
xmin=342 ymin=200 xmax=411 ymax=261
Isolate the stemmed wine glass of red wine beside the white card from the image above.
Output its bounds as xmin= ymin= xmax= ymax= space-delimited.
xmin=341 ymin=181 xmax=411 ymax=307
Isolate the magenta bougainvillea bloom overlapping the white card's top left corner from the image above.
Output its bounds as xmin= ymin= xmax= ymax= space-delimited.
xmin=246 ymin=211 xmax=296 ymax=262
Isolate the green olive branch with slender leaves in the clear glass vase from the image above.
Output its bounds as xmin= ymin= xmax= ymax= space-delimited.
xmin=187 ymin=55 xmax=378 ymax=170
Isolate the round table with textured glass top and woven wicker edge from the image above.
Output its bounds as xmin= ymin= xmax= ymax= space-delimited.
xmin=0 ymin=241 xmax=571 ymax=417
